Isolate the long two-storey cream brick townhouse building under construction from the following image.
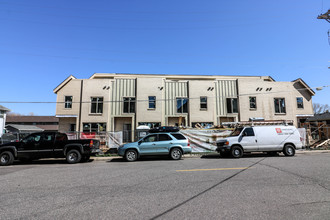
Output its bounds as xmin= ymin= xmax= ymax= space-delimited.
xmin=54 ymin=73 xmax=315 ymax=135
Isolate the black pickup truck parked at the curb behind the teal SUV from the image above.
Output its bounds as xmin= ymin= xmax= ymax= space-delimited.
xmin=0 ymin=132 xmax=100 ymax=166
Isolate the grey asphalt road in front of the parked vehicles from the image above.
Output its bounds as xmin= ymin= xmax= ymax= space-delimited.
xmin=0 ymin=153 xmax=330 ymax=219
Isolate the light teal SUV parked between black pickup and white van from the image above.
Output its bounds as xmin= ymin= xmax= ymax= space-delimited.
xmin=118 ymin=132 xmax=191 ymax=161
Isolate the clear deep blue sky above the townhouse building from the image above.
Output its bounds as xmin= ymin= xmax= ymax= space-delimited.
xmin=0 ymin=0 xmax=330 ymax=115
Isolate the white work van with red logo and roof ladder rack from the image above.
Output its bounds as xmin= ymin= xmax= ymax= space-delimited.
xmin=216 ymin=125 xmax=302 ymax=158
